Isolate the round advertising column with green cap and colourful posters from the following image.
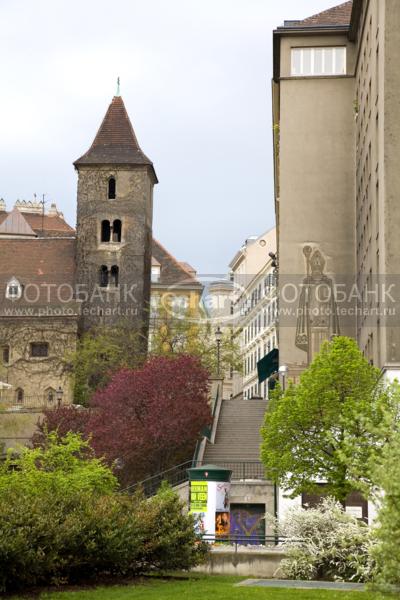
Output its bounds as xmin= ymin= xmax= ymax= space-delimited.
xmin=188 ymin=465 xmax=232 ymax=542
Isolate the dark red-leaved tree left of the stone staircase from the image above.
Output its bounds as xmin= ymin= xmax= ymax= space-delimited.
xmin=35 ymin=356 xmax=211 ymax=483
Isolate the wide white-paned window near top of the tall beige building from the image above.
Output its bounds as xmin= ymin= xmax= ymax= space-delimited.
xmin=291 ymin=47 xmax=346 ymax=77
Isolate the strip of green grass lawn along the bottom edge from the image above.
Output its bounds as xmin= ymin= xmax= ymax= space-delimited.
xmin=14 ymin=575 xmax=400 ymax=600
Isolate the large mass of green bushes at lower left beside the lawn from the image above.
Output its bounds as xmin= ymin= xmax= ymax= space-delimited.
xmin=0 ymin=434 xmax=208 ymax=591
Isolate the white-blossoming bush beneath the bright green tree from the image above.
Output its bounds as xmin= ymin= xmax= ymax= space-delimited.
xmin=277 ymin=498 xmax=373 ymax=582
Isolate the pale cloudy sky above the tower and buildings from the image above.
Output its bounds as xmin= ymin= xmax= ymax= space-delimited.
xmin=0 ymin=0 xmax=339 ymax=275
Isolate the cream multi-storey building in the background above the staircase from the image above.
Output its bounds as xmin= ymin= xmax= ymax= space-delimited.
xmin=229 ymin=229 xmax=277 ymax=399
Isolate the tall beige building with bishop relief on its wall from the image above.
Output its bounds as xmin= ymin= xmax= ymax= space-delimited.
xmin=273 ymin=0 xmax=400 ymax=379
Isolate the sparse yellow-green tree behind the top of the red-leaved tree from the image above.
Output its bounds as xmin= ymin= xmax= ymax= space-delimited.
xmin=150 ymin=307 xmax=242 ymax=375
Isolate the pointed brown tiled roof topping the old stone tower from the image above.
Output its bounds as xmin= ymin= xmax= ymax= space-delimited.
xmin=74 ymin=96 xmax=157 ymax=181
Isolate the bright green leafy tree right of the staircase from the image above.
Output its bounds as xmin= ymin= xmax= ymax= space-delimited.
xmin=261 ymin=337 xmax=400 ymax=503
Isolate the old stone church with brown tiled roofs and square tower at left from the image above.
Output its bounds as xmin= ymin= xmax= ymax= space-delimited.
xmin=0 ymin=96 xmax=202 ymax=408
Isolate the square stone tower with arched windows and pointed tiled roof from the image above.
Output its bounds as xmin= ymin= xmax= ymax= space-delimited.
xmin=74 ymin=95 xmax=157 ymax=335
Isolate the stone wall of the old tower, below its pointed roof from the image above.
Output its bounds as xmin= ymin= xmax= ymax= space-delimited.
xmin=76 ymin=165 xmax=154 ymax=335
